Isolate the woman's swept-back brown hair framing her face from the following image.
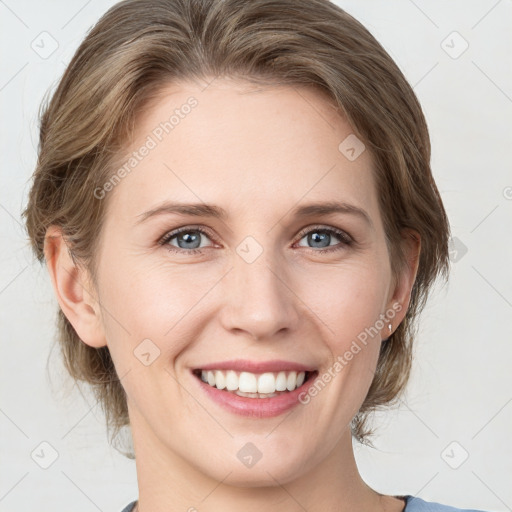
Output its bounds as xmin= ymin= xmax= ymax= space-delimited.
xmin=24 ymin=0 xmax=449 ymax=454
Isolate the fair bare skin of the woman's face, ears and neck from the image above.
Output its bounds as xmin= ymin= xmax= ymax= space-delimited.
xmin=46 ymin=78 xmax=420 ymax=512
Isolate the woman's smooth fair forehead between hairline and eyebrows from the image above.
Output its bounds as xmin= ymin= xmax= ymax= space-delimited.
xmin=106 ymin=79 xmax=378 ymax=223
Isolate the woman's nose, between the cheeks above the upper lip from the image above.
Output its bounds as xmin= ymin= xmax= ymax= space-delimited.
xmin=221 ymin=247 xmax=300 ymax=340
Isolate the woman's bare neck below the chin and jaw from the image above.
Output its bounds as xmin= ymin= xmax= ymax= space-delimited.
xmin=127 ymin=412 xmax=396 ymax=512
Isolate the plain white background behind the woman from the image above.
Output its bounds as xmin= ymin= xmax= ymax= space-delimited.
xmin=0 ymin=0 xmax=512 ymax=512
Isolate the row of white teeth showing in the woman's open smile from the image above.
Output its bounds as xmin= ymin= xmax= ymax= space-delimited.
xmin=192 ymin=369 xmax=318 ymax=398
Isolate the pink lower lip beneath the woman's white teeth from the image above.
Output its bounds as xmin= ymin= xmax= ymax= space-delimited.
xmin=193 ymin=372 xmax=318 ymax=418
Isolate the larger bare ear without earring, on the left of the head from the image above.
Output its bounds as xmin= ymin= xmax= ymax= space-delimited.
xmin=44 ymin=226 xmax=107 ymax=348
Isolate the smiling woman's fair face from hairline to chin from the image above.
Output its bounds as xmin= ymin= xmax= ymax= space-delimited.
xmin=88 ymin=79 xmax=411 ymax=486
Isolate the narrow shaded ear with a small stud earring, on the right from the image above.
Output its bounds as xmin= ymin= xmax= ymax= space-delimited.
xmin=383 ymin=228 xmax=421 ymax=332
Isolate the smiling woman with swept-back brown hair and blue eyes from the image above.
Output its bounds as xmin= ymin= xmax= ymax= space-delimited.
xmin=21 ymin=0 xmax=492 ymax=512
